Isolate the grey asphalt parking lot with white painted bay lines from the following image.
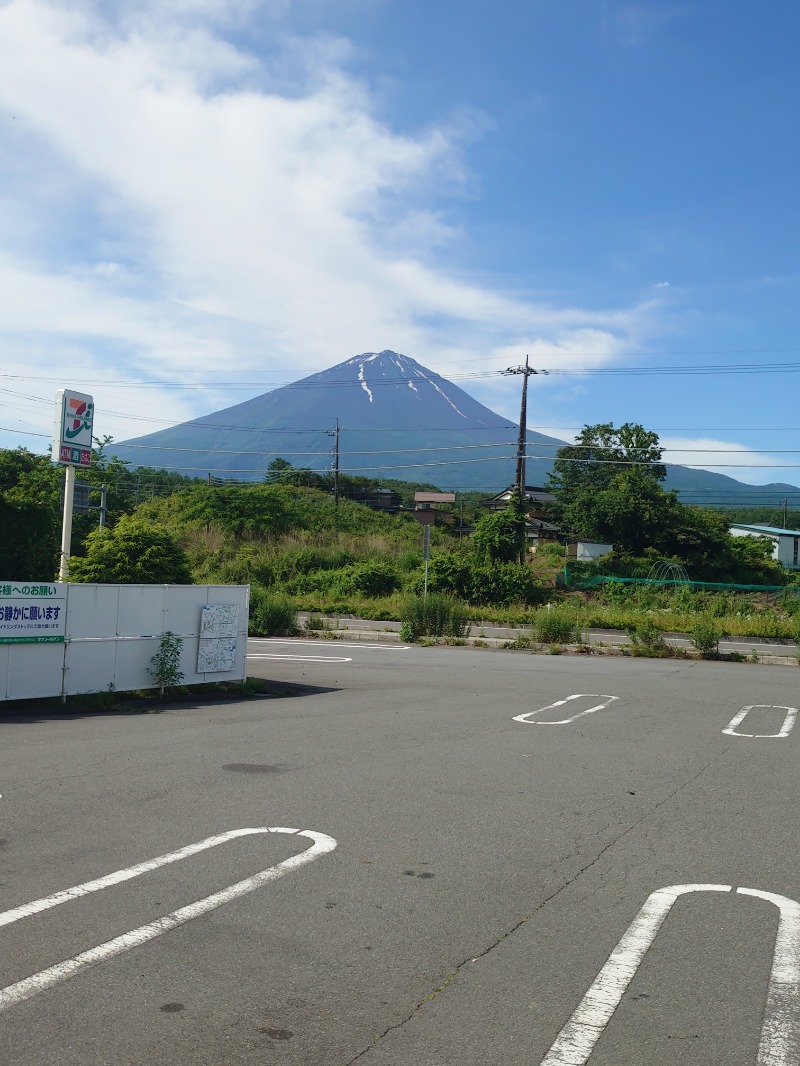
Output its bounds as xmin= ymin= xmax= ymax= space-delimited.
xmin=0 ymin=641 xmax=800 ymax=1066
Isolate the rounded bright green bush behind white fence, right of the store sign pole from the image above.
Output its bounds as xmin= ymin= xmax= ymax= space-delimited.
xmin=69 ymin=515 xmax=192 ymax=585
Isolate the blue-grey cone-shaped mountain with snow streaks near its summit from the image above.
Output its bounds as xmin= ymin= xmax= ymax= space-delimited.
xmin=112 ymin=350 xmax=800 ymax=498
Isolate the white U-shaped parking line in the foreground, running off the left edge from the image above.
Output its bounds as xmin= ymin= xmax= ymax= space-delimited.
xmin=0 ymin=826 xmax=337 ymax=1011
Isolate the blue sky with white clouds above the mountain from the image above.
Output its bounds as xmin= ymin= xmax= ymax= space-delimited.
xmin=0 ymin=0 xmax=800 ymax=485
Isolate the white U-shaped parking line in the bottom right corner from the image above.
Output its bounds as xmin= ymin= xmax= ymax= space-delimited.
xmin=540 ymin=885 xmax=800 ymax=1066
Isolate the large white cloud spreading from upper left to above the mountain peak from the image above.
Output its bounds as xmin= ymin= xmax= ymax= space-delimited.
xmin=0 ymin=0 xmax=660 ymax=438
